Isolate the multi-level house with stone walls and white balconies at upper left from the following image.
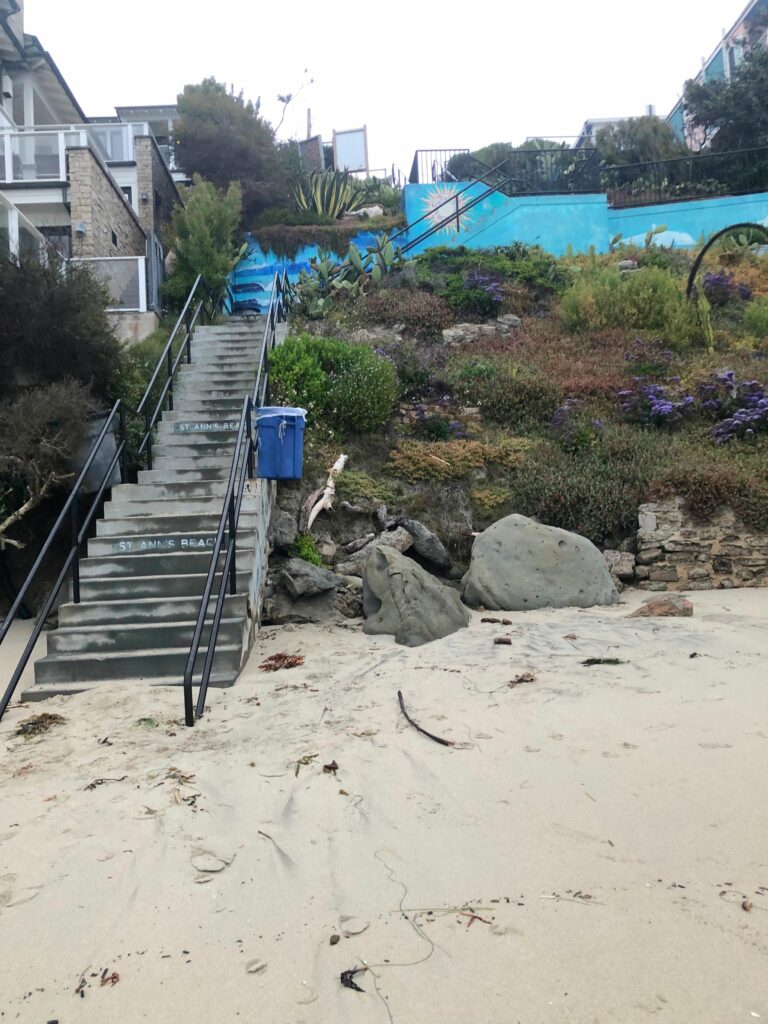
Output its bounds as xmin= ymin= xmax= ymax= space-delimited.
xmin=0 ymin=0 xmax=179 ymax=337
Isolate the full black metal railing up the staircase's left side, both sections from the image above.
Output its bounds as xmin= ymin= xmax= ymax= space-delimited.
xmin=0 ymin=276 xmax=230 ymax=719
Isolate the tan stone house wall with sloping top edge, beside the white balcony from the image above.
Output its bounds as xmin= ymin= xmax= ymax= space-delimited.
xmin=67 ymin=147 xmax=146 ymax=258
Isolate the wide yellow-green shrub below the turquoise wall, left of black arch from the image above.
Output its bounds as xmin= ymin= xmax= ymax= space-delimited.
xmin=559 ymin=267 xmax=699 ymax=344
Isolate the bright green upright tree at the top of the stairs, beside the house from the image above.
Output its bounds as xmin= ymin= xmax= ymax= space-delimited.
xmin=163 ymin=174 xmax=242 ymax=307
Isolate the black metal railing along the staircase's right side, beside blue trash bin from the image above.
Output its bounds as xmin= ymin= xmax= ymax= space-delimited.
xmin=183 ymin=270 xmax=292 ymax=726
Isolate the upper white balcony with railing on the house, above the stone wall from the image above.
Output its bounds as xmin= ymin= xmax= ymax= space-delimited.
xmin=0 ymin=123 xmax=152 ymax=183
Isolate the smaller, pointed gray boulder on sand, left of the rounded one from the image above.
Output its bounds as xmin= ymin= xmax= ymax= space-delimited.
xmin=362 ymin=547 xmax=469 ymax=647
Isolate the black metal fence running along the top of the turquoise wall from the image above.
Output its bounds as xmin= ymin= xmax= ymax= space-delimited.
xmin=411 ymin=146 xmax=768 ymax=209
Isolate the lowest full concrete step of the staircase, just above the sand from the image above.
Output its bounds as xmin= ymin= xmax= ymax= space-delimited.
xmin=35 ymin=644 xmax=243 ymax=686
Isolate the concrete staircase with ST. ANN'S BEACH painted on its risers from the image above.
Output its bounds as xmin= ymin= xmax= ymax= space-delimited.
xmin=24 ymin=317 xmax=286 ymax=699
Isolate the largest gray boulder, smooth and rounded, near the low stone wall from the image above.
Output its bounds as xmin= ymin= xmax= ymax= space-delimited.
xmin=464 ymin=515 xmax=618 ymax=611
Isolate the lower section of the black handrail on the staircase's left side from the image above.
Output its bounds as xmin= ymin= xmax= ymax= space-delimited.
xmin=0 ymin=401 xmax=126 ymax=719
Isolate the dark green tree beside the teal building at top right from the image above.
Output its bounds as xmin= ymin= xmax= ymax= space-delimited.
xmin=684 ymin=46 xmax=768 ymax=153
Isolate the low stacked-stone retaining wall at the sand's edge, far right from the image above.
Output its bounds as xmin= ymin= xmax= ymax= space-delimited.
xmin=635 ymin=498 xmax=768 ymax=591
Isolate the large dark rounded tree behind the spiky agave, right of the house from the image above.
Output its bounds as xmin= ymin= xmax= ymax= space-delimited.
xmin=173 ymin=78 xmax=291 ymax=222
